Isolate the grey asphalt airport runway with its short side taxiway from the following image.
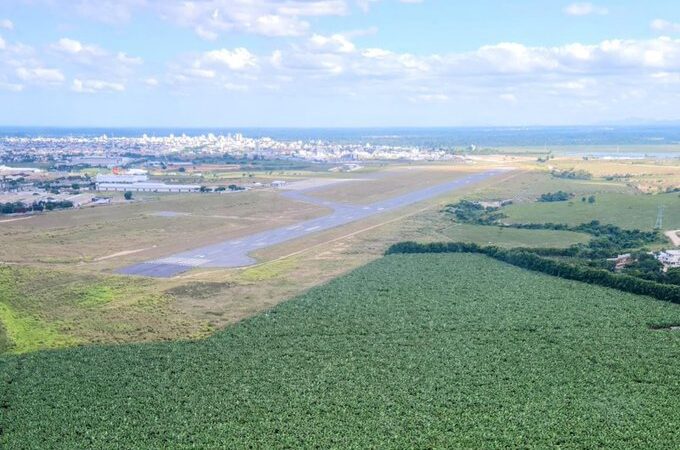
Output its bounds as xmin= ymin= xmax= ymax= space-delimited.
xmin=118 ymin=169 xmax=503 ymax=278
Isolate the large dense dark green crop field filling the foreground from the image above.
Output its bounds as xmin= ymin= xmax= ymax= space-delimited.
xmin=0 ymin=254 xmax=680 ymax=448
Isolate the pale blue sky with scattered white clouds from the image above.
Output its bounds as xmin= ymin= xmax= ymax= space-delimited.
xmin=0 ymin=0 xmax=680 ymax=127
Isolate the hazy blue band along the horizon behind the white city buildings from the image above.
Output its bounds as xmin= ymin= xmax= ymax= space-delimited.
xmin=0 ymin=125 xmax=680 ymax=148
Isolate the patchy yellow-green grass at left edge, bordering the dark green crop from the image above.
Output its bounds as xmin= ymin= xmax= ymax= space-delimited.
xmin=0 ymin=265 xmax=204 ymax=353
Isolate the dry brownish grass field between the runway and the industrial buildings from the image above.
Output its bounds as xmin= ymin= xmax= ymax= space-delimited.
xmin=0 ymin=191 xmax=328 ymax=270
